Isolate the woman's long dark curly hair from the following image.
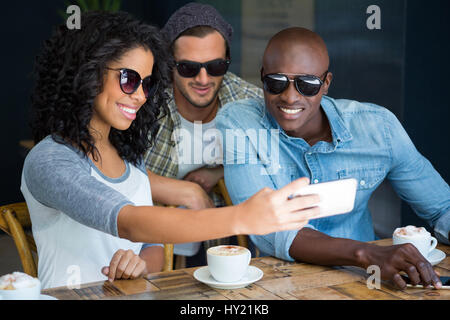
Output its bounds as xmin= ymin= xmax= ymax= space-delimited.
xmin=31 ymin=12 xmax=170 ymax=165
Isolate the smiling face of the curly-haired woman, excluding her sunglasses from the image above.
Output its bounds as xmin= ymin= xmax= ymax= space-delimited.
xmin=90 ymin=47 xmax=154 ymax=137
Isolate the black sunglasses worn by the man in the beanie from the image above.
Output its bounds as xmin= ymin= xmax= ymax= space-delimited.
xmin=176 ymin=59 xmax=231 ymax=78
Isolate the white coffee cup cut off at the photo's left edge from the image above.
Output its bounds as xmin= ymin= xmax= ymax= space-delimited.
xmin=0 ymin=272 xmax=41 ymax=300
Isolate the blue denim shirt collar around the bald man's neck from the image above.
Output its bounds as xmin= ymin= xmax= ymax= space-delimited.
xmin=260 ymin=96 xmax=353 ymax=146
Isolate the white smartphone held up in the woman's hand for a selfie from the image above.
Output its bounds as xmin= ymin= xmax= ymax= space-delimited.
xmin=291 ymin=178 xmax=357 ymax=219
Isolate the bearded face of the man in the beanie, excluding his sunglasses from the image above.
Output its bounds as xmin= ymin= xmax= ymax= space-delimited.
xmin=173 ymin=30 xmax=226 ymax=113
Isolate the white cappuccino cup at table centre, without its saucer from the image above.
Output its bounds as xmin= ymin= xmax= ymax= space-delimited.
xmin=206 ymin=245 xmax=251 ymax=282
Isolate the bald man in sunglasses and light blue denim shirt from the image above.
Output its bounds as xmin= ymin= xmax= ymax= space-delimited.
xmin=217 ymin=28 xmax=450 ymax=288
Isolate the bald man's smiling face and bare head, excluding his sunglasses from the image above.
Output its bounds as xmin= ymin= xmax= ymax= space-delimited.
xmin=262 ymin=29 xmax=332 ymax=141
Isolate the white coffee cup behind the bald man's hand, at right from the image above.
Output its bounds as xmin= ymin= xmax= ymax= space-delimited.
xmin=392 ymin=226 xmax=437 ymax=258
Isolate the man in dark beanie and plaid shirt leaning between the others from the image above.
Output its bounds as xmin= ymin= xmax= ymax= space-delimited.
xmin=145 ymin=3 xmax=263 ymax=264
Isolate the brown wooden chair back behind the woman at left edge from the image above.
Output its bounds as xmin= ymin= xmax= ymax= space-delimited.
xmin=0 ymin=202 xmax=37 ymax=277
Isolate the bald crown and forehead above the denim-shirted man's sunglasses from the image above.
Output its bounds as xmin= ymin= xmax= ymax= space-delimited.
xmin=263 ymin=27 xmax=330 ymax=76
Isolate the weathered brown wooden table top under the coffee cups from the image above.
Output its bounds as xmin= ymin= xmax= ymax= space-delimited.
xmin=42 ymin=239 xmax=450 ymax=300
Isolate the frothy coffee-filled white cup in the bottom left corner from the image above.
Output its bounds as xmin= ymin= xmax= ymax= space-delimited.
xmin=0 ymin=272 xmax=41 ymax=300
